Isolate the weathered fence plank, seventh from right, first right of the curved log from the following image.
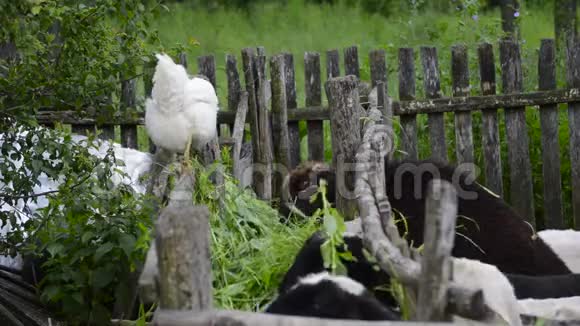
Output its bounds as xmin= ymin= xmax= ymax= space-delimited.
xmin=399 ymin=48 xmax=419 ymax=160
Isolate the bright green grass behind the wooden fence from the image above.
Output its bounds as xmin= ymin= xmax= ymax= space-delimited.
xmin=148 ymin=0 xmax=572 ymax=228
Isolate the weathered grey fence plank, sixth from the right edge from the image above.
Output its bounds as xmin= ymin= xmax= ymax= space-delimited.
xmin=421 ymin=46 xmax=447 ymax=162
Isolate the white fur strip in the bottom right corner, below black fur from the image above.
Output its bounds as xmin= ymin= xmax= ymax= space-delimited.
xmin=518 ymin=297 xmax=580 ymax=320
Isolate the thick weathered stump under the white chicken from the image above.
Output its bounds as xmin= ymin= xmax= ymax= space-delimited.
xmin=156 ymin=173 xmax=212 ymax=312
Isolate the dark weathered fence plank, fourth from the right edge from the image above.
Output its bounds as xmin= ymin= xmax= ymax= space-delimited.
xmin=477 ymin=43 xmax=503 ymax=197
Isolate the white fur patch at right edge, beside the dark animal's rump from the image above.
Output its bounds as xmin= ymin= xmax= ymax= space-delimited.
xmin=538 ymin=230 xmax=580 ymax=273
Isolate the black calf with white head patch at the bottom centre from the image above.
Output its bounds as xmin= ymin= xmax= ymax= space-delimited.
xmin=266 ymin=271 xmax=399 ymax=320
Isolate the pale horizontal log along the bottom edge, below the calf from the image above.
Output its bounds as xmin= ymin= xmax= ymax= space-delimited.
xmin=153 ymin=310 xmax=485 ymax=326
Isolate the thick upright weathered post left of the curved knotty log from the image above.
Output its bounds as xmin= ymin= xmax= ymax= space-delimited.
xmin=325 ymin=75 xmax=362 ymax=219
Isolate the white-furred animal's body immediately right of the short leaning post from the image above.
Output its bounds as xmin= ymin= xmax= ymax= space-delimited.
xmin=453 ymin=258 xmax=521 ymax=326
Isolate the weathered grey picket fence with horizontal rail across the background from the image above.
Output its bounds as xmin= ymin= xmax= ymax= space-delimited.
xmin=34 ymin=39 xmax=580 ymax=229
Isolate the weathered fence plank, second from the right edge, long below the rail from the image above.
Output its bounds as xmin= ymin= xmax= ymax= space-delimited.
xmin=538 ymin=39 xmax=564 ymax=229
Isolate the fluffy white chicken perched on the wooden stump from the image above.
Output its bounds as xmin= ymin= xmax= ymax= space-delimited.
xmin=145 ymin=54 xmax=218 ymax=166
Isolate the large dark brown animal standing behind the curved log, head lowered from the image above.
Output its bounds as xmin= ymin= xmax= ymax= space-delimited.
xmin=289 ymin=160 xmax=570 ymax=275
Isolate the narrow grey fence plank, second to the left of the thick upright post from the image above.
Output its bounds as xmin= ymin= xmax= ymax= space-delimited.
xmin=284 ymin=53 xmax=302 ymax=169
